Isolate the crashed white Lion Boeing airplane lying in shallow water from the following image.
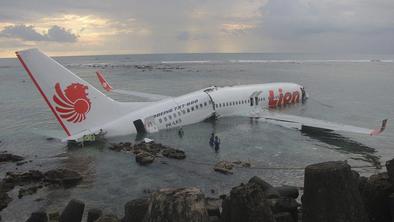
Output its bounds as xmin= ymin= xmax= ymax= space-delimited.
xmin=16 ymin=49 xmax=387 ymax=141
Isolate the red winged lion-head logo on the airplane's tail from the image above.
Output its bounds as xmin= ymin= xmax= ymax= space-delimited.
xmin=53 ymin=83 xmax=91 ymax=123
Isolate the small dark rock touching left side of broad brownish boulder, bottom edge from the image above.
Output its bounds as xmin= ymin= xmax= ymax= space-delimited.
xmin=123 ymin=199 xmax=149 ymax=222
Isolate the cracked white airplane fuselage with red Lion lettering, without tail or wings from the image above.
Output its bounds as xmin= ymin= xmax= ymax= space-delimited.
xmin=102 ymin=83 xmax=306 ymax=136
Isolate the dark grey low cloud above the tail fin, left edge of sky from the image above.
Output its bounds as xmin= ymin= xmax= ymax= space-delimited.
xmin=0 ymin=24 xmax=78 ymax=42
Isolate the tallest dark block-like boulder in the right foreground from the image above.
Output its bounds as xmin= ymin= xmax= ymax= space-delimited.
xmin=302 ymin=161 xmax=368 ymax=222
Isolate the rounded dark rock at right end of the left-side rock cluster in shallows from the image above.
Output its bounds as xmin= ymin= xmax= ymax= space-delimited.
xmin=44 ymin=169 xmax=82 ymax=187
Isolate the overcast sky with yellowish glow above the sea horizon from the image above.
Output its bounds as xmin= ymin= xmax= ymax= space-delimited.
xmin=0 ymin=0 xmax=394 ymax=57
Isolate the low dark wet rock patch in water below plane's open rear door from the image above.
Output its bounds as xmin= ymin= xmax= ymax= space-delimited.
xmin=109 ymin=142 xmax=186 ymax=165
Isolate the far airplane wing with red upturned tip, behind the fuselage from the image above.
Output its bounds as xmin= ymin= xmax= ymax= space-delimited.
xmin=96 ymin=71 xmax=170 ymax=101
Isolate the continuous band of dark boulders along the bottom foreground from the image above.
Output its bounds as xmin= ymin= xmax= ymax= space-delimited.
xmin=13 ymin=159 xmax=394 ymax=222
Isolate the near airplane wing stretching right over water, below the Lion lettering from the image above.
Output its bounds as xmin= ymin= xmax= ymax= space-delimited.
xmin=254 ymin=111 xmax=387 ymax=136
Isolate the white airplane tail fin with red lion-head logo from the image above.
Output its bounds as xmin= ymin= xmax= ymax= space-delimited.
xmin=16 ymin=49 xmax=130 ymax=137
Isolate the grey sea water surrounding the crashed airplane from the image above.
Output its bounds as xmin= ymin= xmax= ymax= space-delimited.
xmin=0 ymin=54 xmax=394 ymax=221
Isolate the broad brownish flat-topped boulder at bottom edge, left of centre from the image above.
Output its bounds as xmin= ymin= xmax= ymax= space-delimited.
xmin=144 ymin=187 xmax=209 ymax=222
